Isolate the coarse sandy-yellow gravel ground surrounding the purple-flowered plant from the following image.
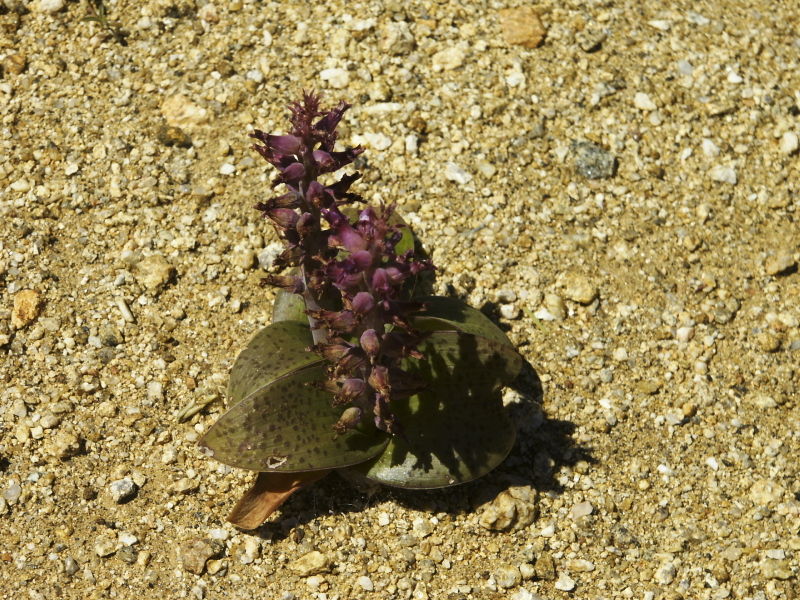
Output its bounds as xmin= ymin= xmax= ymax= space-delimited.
xmin=0 ymin=0 xmax=800 ymax=600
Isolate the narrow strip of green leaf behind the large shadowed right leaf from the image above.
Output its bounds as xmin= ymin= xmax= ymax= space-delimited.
xmin=413 ymin=296 xmax=522 ymax=383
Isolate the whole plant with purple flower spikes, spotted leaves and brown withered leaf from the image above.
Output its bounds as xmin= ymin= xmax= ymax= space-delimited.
xmin=201 ymin=93 xmax=522 ymax=529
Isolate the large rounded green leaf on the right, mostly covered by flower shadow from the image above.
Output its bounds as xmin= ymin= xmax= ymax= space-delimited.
xmin=353 ymin=331 xmax=516 ymax=488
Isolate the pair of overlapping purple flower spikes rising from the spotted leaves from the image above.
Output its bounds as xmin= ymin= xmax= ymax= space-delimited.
xmin=252 ymin=92 xmax=433 ymax=434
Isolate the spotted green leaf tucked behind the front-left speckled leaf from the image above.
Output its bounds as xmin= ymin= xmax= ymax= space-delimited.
xmin=228 ymin=315 xmax=322 ymax=402
